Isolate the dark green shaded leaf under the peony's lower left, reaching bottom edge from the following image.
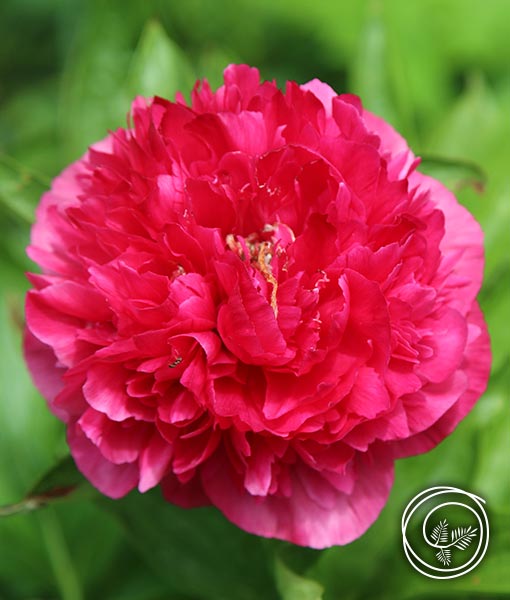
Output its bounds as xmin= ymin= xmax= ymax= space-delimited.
xmin=99 ymin=490 xmax=277 ymax=600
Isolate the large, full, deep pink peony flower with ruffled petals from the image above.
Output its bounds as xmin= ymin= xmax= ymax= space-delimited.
xmin=25 ymin=66 xmax=490 ymax=548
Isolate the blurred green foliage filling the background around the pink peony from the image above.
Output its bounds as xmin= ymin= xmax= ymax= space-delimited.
xmin=0 ymin=0 xmax=510 ymax=600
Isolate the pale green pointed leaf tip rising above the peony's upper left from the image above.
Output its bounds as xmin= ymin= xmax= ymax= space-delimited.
xmin=126 ymin=21 xmax=195 ymax=100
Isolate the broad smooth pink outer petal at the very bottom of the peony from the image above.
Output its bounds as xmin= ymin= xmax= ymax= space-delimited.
xmin=202 ymin=449 xmax=393 ymax=548
